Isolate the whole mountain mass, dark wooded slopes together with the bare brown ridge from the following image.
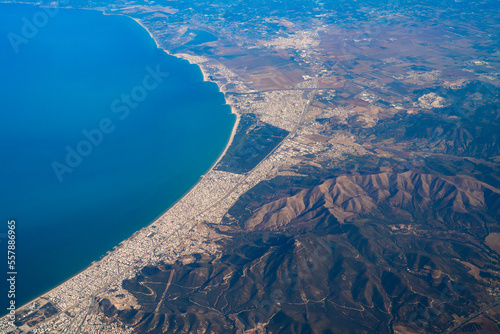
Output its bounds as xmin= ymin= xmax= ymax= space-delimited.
xmin=100 ymin=172 xmax=500 ymax=333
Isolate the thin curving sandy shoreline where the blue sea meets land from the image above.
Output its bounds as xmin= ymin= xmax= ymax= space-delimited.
xmin=0 ymin=1 xmax=240 ymax=320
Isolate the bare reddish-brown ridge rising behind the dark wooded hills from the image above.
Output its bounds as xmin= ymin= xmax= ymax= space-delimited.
xmin=244 ymin=171 xmax=500 ymax=232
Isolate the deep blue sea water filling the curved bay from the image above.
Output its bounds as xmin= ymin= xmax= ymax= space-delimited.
xmin=0 ymin=4 xmax=234 ymax=314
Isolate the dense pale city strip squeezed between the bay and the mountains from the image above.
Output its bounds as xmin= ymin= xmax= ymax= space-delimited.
xmin=0 ymin=56 xmax=368 ymax=333
